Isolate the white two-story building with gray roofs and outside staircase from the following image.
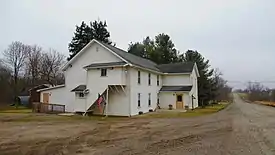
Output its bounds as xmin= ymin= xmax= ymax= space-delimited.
xmin=38 ymin=40 xmax=199 ymax=116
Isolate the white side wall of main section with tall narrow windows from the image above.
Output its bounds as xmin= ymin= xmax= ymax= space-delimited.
xmin=129 ymin=68 xmax=162 ymax=115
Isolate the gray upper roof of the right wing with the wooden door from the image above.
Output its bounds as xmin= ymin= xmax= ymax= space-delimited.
xmin=158 ymin=62 xmax=194 ymax=73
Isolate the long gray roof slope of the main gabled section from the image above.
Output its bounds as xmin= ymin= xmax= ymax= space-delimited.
xmin=100 ymin=42 xmax=160 ymax=72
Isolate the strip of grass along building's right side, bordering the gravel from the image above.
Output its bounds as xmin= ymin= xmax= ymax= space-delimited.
xmin=139 ymin=103 xmax=229 ymax=118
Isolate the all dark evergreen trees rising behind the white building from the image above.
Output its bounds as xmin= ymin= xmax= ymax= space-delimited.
xmin=67 ymin=20 xmax=232 ymax=105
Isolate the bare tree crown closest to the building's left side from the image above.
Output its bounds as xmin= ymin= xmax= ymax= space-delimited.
xmin=40 ymin=49 xmax=65 ymax=85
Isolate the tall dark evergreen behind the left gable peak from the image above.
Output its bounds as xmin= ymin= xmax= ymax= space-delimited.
xmin=67 ymin=21 xmax=112 ymax=60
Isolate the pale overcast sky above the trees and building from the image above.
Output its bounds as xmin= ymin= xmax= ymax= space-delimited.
xmin=0 ymin=0 xmax=275 ymax=86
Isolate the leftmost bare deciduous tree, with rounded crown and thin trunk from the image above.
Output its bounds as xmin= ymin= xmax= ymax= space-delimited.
xmin=3 ymin=41 xmax=29 ymax=96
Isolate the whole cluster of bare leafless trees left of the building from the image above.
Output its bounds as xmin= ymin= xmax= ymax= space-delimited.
xmin=0 ymin=41 xmax=65 ymax=102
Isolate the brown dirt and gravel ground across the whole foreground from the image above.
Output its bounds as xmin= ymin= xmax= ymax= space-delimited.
xmin=0 ymin=96 xmax=275 ymax=155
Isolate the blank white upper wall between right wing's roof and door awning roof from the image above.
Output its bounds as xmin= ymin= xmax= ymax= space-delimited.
xmin=162 ymin=74 xmax=192 ymax=86
